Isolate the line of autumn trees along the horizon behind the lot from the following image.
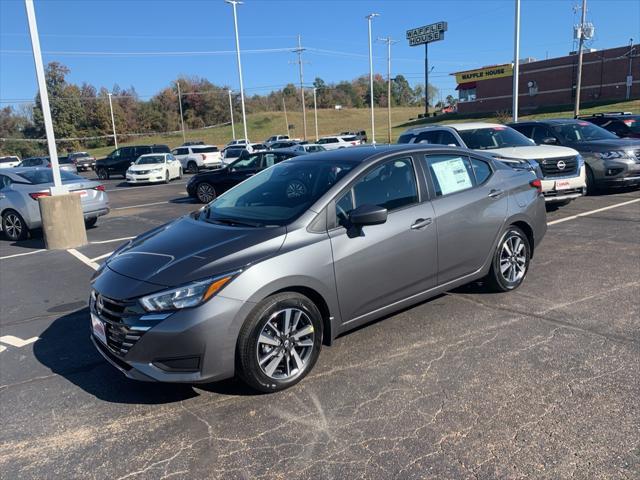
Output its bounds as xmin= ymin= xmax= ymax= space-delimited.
xmin=0 ymin=62 xmax=438 ymax=158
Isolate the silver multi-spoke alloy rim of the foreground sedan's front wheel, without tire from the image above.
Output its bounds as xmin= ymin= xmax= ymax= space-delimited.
xmin=257 ymin=308 xmax=315 ymax=380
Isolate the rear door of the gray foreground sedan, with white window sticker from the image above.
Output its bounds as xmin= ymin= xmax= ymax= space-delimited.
xmin=422 ymin=152 xmax=508 ymax=285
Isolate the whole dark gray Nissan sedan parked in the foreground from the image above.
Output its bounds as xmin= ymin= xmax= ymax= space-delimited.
xmin=90 ymin=144 xmax=546 ymax=392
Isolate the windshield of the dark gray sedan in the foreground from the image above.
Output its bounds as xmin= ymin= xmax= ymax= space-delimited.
xmin=200 ymin=160 xmax=355 ymax=227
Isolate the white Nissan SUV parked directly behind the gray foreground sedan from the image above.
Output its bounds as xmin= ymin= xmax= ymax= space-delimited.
xmin=398 ymin=122 xmax=587 ymax=205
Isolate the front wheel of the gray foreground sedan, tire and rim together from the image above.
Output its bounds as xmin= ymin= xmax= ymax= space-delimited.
xmin=237 ymin=292 xmax=323 ymax=393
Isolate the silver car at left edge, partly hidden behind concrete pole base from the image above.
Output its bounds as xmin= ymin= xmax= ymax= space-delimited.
xmin=0 ymin=167 xmax=109 ymax=241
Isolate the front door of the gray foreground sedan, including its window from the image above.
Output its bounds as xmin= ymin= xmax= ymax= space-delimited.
xmin=328 ymin=154 xmax=437 ymax=322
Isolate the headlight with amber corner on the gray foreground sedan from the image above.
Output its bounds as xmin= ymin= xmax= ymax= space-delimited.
xmin=140 ymin=271 xmax=240 ymax=312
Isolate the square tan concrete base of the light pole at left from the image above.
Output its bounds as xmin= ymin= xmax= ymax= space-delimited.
xmin=38 ymin=193 xmax=88 ymax=250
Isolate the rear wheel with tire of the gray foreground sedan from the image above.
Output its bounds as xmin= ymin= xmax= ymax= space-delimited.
xmin=487 ymin=226 xmax=531 ymax=292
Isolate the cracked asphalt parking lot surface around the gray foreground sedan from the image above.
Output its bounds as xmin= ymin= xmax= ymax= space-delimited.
xmin=0 ymin=178 xmax=640 ymax=480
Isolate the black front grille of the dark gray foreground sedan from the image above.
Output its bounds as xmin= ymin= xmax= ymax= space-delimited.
xmin=91 ymin=294 xmax=144 ymax=356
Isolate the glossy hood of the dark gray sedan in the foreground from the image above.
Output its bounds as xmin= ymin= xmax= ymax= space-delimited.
xmin=107 ymin=216 xmax=286 ymax=287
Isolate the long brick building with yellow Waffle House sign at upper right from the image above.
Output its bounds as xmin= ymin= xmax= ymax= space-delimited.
xmin=452 ymin=44 xmax=640 ymax=114
